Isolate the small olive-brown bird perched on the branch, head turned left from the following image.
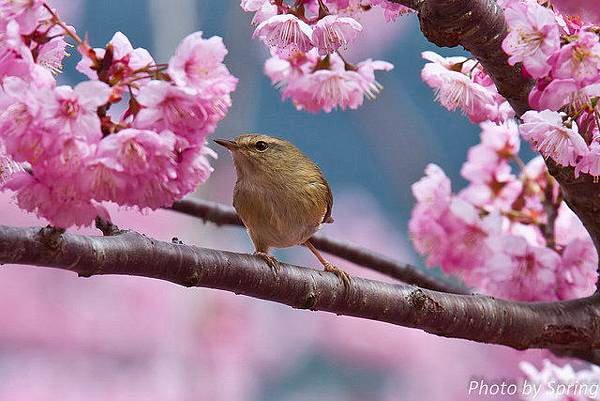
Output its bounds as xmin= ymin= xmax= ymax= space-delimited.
xmin=215 ymin=134 xmax=350 ymax=286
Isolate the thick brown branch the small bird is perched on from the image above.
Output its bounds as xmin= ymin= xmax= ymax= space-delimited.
xmin=0 ymin=226 xmax=600 ymax=350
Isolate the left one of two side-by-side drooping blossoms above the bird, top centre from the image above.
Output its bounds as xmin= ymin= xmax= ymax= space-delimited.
xmin=253 ymin=14 xmax=313 ymax=58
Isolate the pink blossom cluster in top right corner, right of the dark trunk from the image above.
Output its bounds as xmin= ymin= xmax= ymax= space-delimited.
xmin=502 ymin=0 xmax=600 ymax=177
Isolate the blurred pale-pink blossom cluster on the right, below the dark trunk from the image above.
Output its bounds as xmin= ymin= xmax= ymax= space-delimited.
xmin=409 ymin=122 xmax=598 ymax=301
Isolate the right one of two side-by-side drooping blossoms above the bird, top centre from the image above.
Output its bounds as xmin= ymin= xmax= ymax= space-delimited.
xmin=312 ymin=15 xmax=362 ymax=55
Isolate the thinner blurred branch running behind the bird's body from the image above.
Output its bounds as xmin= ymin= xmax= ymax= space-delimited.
xmin=171 ymin=198 xmax=468 ymax=294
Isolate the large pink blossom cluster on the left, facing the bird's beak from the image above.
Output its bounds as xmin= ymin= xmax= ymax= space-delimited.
xmin=0 ymin=0 xmax=237 ymax=227
